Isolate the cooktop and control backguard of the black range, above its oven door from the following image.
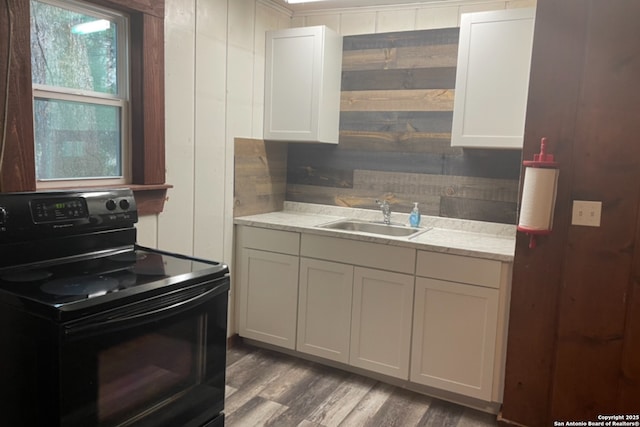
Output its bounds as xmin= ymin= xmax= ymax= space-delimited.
xmin=0 ymin=190 xmax=229 ymax=321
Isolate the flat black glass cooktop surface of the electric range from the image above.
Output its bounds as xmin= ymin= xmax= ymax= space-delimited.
xmin=0 ymin=247 xmax=229 ymax=320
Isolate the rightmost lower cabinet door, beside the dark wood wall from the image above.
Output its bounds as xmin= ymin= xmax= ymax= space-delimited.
xmin=410 ymin=277 xmax=499 ymax=401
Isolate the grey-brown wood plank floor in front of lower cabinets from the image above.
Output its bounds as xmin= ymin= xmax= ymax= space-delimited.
xmin=225 ymin=342 xmax=497 ymax=427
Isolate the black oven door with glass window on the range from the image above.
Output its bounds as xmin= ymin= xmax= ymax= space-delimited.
xmin=59 ymin=277 xmax=229 ymax=427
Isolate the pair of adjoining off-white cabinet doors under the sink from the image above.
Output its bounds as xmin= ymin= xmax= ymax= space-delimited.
xmin=296 ymin=258 xmax=413 ymax=380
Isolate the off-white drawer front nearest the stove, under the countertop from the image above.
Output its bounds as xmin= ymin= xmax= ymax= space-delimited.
xmin=236 ymin=226 xmax=300 ymax=255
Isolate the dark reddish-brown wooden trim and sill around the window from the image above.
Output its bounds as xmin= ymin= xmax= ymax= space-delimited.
xmin=0 ymin=0 xmax=171 ymax=215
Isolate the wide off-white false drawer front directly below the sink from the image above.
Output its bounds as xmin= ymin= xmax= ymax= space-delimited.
xmin=300 ymin=234 xmax=416 ymax=274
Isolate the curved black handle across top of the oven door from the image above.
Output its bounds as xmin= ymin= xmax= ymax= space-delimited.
xmin=64 ymin=281 xmax=229 ymax=339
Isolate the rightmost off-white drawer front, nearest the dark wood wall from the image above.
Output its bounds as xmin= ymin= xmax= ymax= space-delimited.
xmin=416 ymin=251 xmax=502 ymax=288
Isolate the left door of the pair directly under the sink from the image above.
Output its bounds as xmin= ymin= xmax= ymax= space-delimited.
xmin=297 ymin=258 xmax=353 ymax=363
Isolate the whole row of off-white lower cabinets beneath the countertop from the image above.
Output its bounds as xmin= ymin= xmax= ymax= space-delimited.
xmin=236 ymin=226 xmax=511 ymax=403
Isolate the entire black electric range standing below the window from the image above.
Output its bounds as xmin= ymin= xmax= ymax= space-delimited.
xmin=0 ymin=189 xmax=230 ymax=427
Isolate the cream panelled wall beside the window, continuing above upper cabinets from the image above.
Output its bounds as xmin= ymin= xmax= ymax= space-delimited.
xmin=138 ymin=0 xmax=535 ymax=333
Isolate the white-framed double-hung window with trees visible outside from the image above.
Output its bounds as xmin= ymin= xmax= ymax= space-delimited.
xmin=30 ymin=0 xmax=130 ymax=187
